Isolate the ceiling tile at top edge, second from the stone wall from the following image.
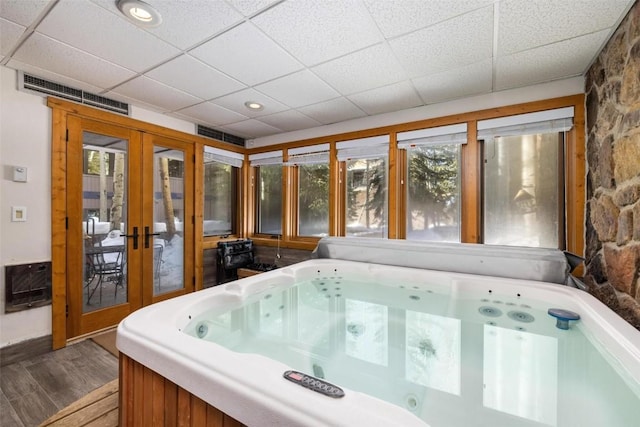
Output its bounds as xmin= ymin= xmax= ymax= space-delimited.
xmin=365 ymin=0 xmax=494 ymax=38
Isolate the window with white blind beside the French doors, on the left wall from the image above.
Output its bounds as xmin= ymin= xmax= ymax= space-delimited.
xmin=203 ymin=146 xmax=244 ymax=236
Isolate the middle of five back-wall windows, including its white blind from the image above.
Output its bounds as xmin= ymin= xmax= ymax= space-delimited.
xmin=336 ymin=135 xmax=389 ymax=238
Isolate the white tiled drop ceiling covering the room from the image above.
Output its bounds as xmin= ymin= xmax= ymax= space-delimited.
xmin=0 ymin=0 xmax=635 ymax=142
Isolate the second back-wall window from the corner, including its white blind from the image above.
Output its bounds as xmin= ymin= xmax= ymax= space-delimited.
xmin=286 ymin=144 xmax=329 ymax=237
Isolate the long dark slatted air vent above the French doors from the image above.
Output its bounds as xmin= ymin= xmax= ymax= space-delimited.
xmin=18 ymin=71 xmax=129 ymax=116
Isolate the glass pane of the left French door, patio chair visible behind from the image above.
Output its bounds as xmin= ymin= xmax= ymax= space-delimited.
xmin=82 ymin=131 xmax=128 ymax=313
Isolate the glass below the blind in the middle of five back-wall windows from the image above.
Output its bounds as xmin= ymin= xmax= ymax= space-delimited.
xmin=345 ymin=156 xmax=387 ymax=238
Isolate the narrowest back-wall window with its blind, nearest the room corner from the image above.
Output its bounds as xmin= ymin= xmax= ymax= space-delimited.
xmin=249 ymin=151 xmax=282 ymax=235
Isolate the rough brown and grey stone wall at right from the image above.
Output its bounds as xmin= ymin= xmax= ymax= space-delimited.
xmin=584 ymin=2 xmax=640 ymax=329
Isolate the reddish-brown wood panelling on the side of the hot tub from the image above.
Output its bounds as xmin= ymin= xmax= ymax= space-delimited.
xmin=119 ymin=353 xmax=244 ymax=427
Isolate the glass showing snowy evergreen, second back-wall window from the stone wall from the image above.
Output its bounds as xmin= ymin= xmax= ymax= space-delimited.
xmin=406 ymin=144 xmax=460 ymax=242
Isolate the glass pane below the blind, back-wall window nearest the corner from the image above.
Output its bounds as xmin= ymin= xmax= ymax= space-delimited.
xmin=256 ymin=164 xmax=282 ymax=235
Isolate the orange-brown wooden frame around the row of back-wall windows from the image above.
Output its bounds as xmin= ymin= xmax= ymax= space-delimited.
xmin=246 ymin=94 xmax=586 ymax=264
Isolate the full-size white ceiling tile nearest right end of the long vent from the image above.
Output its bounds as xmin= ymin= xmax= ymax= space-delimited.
xmin=113 ymin=76 xmax=203 ymax=111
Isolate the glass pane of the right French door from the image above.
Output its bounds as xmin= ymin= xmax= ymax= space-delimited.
xmin=152 ymin=145 xmax=186 ymax=296
